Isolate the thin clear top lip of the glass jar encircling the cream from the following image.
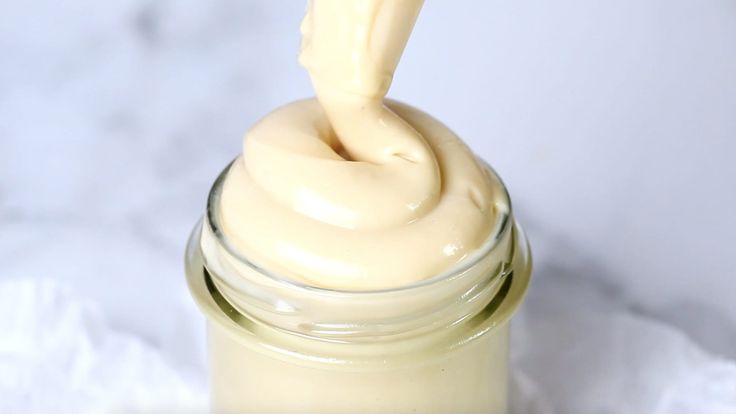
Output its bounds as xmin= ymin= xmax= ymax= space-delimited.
xmin=205 ymin=156 xmax=514 ymax=297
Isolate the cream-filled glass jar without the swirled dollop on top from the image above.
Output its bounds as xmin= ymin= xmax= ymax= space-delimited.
xmin=186 ymin=160 xmax=531 ymax=413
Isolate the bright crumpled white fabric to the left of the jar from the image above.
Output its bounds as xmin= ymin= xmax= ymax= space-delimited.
xmin=0 ymin=279 xmax=207 ymax=414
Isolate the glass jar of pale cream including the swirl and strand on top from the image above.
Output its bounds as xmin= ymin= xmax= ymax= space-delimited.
xmin=188 ymin=0 xmax=530 ymax=413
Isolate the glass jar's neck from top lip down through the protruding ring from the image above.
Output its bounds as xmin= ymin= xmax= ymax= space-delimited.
xmin=187 ymin=162 xmax=530 ymax=366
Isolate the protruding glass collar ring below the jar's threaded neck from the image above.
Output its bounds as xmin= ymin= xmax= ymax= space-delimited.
xmin=185 ymin=218 xmax=532 ymax=369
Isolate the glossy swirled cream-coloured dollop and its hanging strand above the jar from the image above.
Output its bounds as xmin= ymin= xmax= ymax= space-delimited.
xmin=219 ymin=0 xmax=496 ymax=290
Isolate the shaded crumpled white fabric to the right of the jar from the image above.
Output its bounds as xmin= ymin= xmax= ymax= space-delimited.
xmin=511 ymin=272 xmax=736 ymax=414
